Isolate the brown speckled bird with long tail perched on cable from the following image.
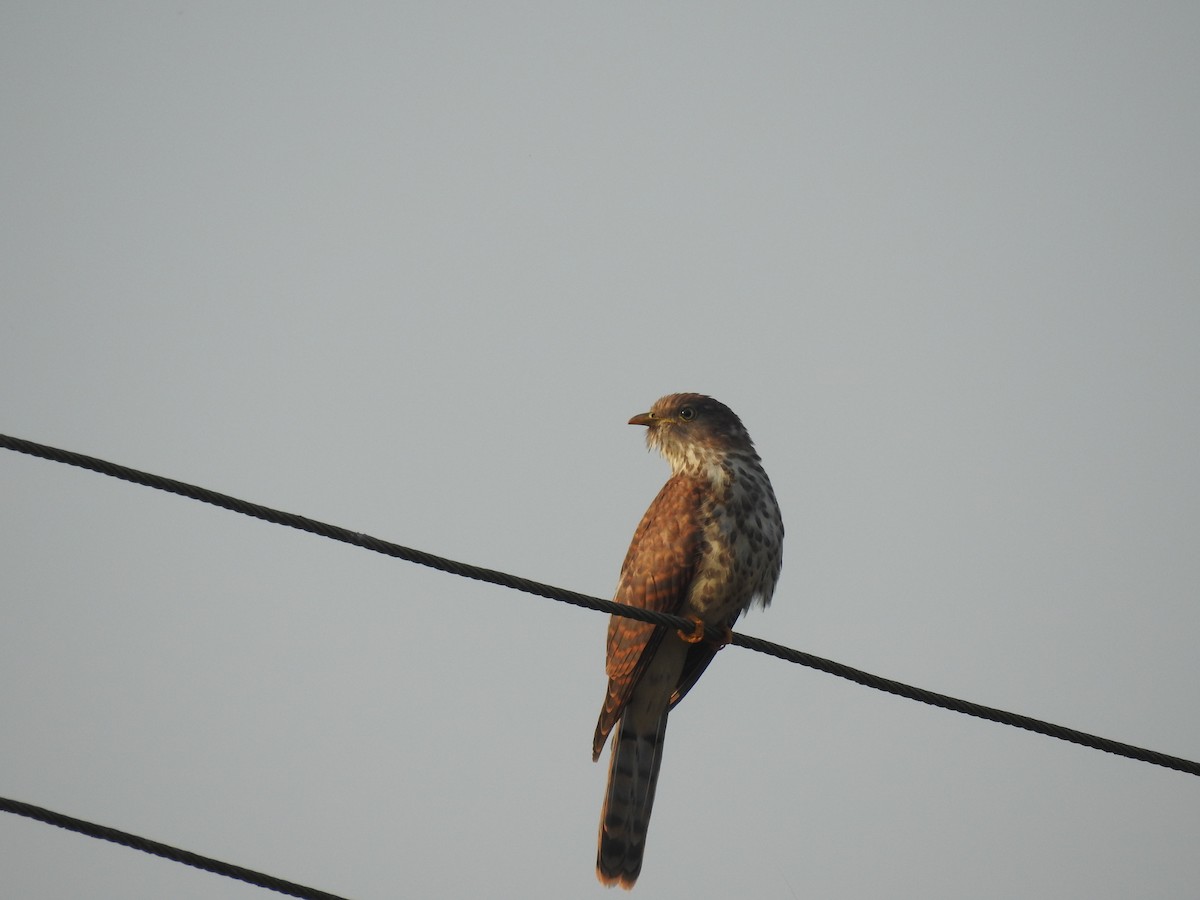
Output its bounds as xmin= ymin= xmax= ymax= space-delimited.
xmin=592 ymin=394 xmax=784 ymax=890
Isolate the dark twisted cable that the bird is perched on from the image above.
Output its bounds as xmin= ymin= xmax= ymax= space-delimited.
xmin=7 ymin=434 xmax=1200 ymax=775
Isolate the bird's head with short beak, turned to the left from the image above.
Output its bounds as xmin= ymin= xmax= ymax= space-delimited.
xmin=629 ymin=394 xmax=757 ymax=475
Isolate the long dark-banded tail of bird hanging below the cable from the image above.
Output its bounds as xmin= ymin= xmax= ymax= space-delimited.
xmin=596 ymin=709 xmax=668 ymax=890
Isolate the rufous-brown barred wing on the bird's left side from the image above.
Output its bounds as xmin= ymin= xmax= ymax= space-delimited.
xmin=592 ymin=475 xmax=704 ymax=757
